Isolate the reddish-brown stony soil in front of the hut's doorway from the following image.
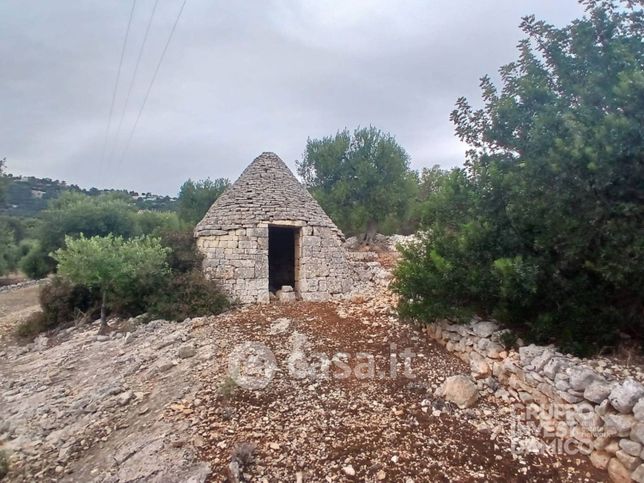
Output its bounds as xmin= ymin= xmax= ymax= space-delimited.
xmin=173 ymin=300 xmax=606 ymax=483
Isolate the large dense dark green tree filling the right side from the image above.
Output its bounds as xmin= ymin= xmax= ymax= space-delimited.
xmin=398 ymin=0 xmax=644 ymax=353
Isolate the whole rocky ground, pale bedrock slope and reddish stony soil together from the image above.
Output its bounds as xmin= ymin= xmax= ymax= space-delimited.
xmin=0 ymin=280 xmax=605 ymax=482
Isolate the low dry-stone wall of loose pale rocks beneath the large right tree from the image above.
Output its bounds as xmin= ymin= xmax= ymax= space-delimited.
xmin=426 ymin=320 xmax=644 ymax=483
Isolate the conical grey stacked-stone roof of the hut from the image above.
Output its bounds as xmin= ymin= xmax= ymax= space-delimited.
xmin=195 ymin=153 xmax=342 ymax=236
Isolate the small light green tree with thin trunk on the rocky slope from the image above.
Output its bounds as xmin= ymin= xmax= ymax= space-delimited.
xmin=54 ymin=235 xmax=169 ymax=332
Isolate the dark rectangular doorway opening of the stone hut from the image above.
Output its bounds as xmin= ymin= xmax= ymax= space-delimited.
xmin=268 ymin=226 xmax=300 ymax=292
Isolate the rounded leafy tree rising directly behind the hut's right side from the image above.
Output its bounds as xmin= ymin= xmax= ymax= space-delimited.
xmin=297 ymin=127 xmax=416 ymax=242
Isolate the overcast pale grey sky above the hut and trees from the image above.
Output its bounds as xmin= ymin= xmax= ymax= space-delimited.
xmin=0 ymin=0 xmax=582 ymax=194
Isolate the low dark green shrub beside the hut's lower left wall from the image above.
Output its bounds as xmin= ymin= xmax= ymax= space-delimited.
xmin=147 ymin=270 xmax=229 ymax=320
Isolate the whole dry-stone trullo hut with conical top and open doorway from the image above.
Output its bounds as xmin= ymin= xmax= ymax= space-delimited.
xmin=195 ymin=153 xmax=352 ymax=303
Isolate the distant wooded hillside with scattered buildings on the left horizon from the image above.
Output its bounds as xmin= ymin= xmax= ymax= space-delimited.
xmin=0 ymin=174 xmax=177 ymax=216
